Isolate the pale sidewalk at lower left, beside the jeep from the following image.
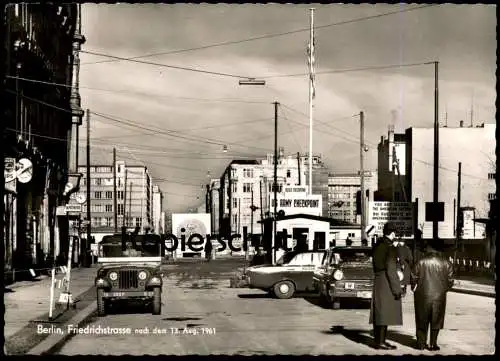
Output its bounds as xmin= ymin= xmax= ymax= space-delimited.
xmin=4 ymin=265 xmax=96 ymax=352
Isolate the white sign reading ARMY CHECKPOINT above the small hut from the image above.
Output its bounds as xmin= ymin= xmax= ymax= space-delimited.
xmin=269 ymin=193 xmax=323 ymax=216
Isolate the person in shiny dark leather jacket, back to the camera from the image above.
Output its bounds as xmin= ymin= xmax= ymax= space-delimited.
xmin=411 ymin=240 xmax=454 ymax=351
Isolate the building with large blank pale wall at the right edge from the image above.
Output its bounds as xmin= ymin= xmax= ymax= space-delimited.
xmin=378 ymin=121 xmax=496 ymax=238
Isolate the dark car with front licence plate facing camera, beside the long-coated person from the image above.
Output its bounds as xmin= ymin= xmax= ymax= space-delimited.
xmin=313 ymin=247 xmax=373 ymax=309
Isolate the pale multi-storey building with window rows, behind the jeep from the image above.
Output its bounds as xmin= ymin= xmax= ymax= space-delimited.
xmin=79 ymin=161 xmax=153 ymax=242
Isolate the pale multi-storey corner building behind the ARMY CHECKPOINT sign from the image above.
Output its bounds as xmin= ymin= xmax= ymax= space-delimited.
xmin=217 ymin=148 xmax=328 ymax=235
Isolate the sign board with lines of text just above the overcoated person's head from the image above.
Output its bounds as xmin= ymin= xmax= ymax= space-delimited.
xmin=368 ymin=202 xmax=413 ymax=237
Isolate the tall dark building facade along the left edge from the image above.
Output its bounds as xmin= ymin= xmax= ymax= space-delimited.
xmin=1 ymin=3 xmax=84 ymax=274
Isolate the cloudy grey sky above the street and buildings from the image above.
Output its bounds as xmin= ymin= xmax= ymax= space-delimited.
xmin=80 ymin=3 xmax=496 ymax=212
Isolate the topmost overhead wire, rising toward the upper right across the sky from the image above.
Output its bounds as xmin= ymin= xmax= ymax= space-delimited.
xmin=81 ymin=4 xmax=438 ymax=65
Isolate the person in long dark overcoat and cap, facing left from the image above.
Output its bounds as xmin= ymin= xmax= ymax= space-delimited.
xmin=370 ymin=223 xmax=403 ymax=350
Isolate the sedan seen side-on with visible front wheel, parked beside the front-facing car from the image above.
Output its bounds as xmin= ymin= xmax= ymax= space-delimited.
xmin=245 ymin=251 xmax=325 ymax=299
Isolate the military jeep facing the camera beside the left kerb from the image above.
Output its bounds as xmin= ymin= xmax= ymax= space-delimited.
xmin=95 ymin=234 xmax=163 ymax=316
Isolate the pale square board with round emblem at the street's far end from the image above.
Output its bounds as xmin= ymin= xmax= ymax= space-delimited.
xmin=172 ymin=213 xmax=211 ymax=255
